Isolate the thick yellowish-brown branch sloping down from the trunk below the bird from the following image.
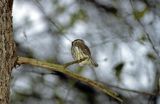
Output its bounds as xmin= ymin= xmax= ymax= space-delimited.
xmin=17 ymin=57 xmax=123 ymax=102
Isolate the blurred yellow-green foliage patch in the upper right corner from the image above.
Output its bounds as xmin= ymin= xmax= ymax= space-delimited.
xmin=133 ymin=7 xmax=148 ymax=20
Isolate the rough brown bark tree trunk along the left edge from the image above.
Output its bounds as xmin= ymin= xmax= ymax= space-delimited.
xmin=0 ymin=0 xmax=16 ymax=104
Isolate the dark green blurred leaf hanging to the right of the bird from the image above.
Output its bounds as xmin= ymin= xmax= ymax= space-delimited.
xmin=114 ymin=62 xmax=124 ymax=80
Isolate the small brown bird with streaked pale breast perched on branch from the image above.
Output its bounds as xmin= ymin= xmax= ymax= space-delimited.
xmin=71 ymin=39 xmax=98 ymax=67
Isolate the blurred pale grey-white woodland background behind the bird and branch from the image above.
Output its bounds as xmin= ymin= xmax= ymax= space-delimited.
xmin=11 ymin=0 xmax=160 ymax=104
